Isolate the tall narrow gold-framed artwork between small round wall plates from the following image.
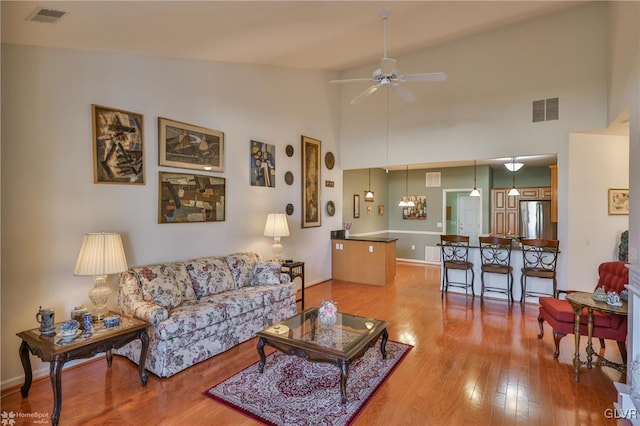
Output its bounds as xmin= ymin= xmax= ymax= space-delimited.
xmin=302 ymin=136 xmax=322 ymax=228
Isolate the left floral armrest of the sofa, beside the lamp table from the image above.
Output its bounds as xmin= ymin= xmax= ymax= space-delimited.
xmin=118 ymin=271 xmax=169 ymax=326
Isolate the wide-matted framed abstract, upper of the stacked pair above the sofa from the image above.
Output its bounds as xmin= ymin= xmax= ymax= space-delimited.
xmin=158 ymin=117 xmax=224 ymax=172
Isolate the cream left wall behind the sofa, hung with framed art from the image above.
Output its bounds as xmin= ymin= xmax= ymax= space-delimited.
xmin=1 ymin=45 xmax=342 ymax=387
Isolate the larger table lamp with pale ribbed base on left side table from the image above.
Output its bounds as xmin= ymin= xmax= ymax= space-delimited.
xmin=73 ymin=232 xmax=128 ymax=320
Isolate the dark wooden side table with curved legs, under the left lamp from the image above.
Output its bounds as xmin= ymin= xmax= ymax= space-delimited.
xmin=17 ymin=315 xmax=149 ymax=425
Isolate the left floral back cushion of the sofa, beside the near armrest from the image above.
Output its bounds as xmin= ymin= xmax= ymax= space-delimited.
xmin=131 ymin=263 xmax=183 ymax=310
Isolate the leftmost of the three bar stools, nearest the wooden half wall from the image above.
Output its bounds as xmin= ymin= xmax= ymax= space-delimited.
xmin=440 ymin=235 xmax=476 ymax=297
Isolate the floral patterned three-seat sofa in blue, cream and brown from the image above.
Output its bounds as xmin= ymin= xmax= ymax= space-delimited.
xmin=115 ymin=253 xmax=297 ymax=377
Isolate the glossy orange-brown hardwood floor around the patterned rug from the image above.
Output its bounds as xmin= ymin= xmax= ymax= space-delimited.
xmin=2 ymin=263 xmax=625 ymax=426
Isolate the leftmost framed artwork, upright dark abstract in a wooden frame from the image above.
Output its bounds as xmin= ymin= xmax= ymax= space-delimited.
xmin=91 ymin=104 xmax=144 ymax=185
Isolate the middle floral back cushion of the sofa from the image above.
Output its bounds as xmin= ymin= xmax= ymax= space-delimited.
xmin=187 ymin=257 xmax=235 ymax=299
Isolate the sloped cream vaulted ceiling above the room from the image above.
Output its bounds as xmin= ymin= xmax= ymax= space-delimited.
xmin=1 ymin=0 xmax=581 ymax=71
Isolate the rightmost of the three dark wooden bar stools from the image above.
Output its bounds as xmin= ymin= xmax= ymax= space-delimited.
xmin=520 ymin=238 xmax=560 ymax=303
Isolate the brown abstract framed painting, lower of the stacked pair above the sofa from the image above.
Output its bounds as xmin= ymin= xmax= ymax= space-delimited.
xmin=158 ymin=172 xmax=226 ymax=223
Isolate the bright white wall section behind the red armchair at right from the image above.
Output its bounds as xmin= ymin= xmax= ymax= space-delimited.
xmin=561 ymin=133 xmax=629 ymax=291
